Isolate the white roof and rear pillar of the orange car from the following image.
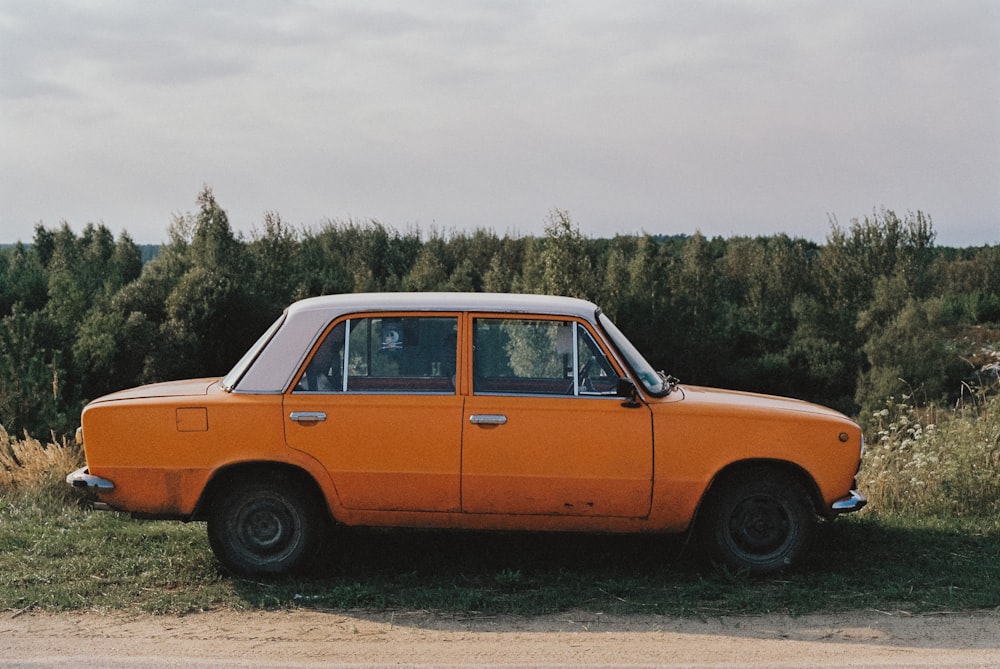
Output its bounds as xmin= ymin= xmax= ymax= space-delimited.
xmin=227 ymin=293 xmax=597 ymax=393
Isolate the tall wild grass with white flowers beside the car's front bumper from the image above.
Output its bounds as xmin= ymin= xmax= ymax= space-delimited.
xmin=859 ymin=391 xmax=1000 ymax=519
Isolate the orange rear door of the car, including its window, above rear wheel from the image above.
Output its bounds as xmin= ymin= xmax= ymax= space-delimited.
xmin=284 ymin=314 xmax=462 ymax=511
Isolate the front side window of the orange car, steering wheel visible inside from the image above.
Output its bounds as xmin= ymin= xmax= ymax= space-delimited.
xmin=472 ymin=318 xmax=618 ymax=395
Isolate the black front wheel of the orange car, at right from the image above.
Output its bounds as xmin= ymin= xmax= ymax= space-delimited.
xmin=699 ymin=469 xmax=816 ymax=574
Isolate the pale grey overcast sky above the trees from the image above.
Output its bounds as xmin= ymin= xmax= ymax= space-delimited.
xmin=0 ymin=0 xmax=1000 ymax=247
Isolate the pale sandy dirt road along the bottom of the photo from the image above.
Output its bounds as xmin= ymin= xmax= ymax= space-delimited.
xmin=0 ymin=610 xmax=1000 ymax=669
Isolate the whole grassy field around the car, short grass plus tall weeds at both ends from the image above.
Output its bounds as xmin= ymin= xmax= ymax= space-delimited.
xmin=0 ymin=392 xmax=1000 ymax=618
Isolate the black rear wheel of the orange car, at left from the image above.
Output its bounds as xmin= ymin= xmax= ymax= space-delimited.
xmin=208 ymin=475 xmax=324 ymax=576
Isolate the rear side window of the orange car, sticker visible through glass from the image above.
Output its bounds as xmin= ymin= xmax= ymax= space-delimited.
xmin=296 ymin=316 xmax=458 ymax=393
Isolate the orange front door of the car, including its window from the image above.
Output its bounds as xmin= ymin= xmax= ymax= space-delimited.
xmin=462 ymin=315 xmax=653 ymax=518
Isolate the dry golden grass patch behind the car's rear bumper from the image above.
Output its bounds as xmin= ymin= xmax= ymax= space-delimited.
xmin=0 ymin=426 xmax=83 ymax=500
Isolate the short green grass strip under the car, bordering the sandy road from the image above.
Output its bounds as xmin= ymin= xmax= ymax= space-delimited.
xmin=0 ymin=490 xmax=1000 ymax=617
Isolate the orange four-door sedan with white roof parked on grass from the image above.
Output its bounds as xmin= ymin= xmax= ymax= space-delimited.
xmin=67 ymin=293 xmax=866 ymax=575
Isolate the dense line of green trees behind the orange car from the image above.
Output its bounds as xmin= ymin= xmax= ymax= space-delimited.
xmin=0 ymin=188 xmax=1000 ymax=434
